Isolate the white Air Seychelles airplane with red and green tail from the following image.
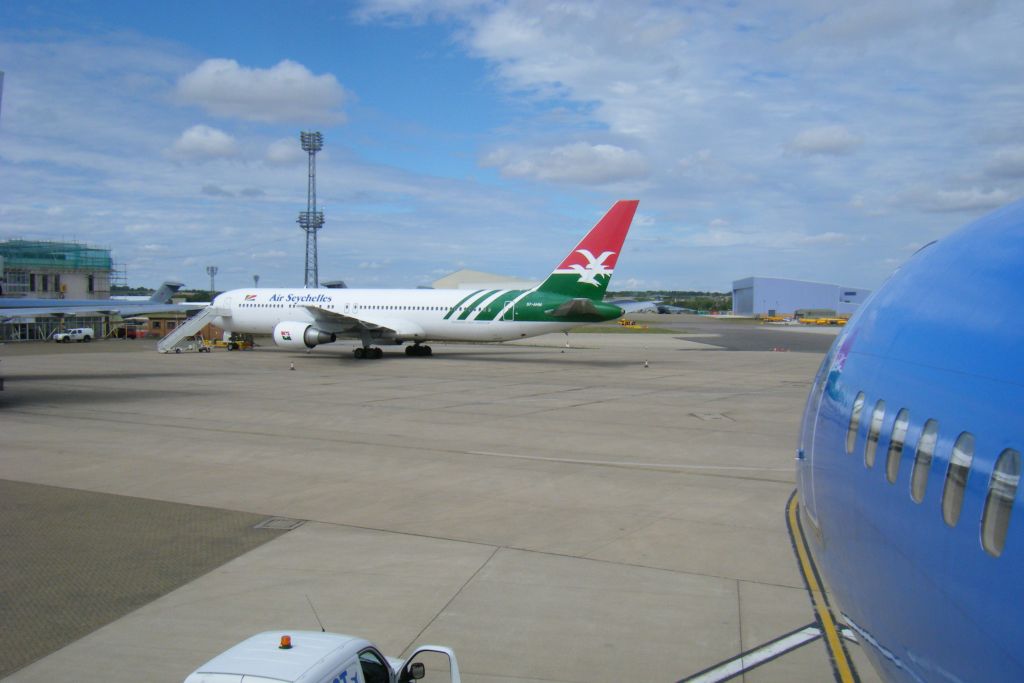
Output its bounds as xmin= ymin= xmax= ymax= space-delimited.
xmin=210 ymin=200 xmax=639 ymax=358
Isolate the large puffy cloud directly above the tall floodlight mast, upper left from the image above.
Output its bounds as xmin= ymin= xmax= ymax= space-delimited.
xmin=177 ymin=59 xmax=345 ymax=124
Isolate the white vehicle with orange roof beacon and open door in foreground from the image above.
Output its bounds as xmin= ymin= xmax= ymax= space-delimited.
xmin=185 ymin=631 xmax=461 ymax=683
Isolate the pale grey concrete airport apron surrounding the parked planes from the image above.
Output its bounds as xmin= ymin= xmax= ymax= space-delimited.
xmin=0 ymin=315 xmax=874 ymax=683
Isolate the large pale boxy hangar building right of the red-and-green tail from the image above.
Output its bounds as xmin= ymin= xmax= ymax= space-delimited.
xmin=732 ymin=278 xmax=871 ymax=315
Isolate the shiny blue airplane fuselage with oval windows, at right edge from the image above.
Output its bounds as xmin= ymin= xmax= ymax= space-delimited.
xmin=797 ymin=201 xmax=1024 ymax=681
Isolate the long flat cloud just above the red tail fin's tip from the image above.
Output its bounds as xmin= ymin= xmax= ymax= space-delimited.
xmin=480 ymin=142 xmax=647 ymax=185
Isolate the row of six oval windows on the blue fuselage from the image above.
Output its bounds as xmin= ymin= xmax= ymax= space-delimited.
xmin=846 ymin=391 xmax=1021 ymax=557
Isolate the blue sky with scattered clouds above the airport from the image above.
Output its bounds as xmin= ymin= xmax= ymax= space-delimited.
xmin=0 ymin=0 xmax=1024 ymax=290
